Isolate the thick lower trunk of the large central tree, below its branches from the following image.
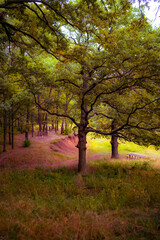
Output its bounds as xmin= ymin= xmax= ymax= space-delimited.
xmin=78 ymin=128 xmax=87 ymax=173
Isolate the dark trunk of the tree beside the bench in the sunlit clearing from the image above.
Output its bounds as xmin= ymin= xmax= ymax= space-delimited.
xmin=111 ymin=120 xmax=119 ymax=158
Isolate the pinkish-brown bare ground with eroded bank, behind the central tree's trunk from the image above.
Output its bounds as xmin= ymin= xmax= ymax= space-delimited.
xmin=0 ymin=132 xmax=106 ymax=170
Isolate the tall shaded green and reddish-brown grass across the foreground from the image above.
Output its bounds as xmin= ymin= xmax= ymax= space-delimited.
xmin=0 ymin=160 xmax=160 ymax=240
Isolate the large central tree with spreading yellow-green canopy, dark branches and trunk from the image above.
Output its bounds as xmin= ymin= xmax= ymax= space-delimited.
xmin=0 ymin=0 xmax=160 ymax=172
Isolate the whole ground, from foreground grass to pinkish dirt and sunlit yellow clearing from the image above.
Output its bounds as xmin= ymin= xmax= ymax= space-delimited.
xmin=0 ymin=132 xmax=160 ymax=240
